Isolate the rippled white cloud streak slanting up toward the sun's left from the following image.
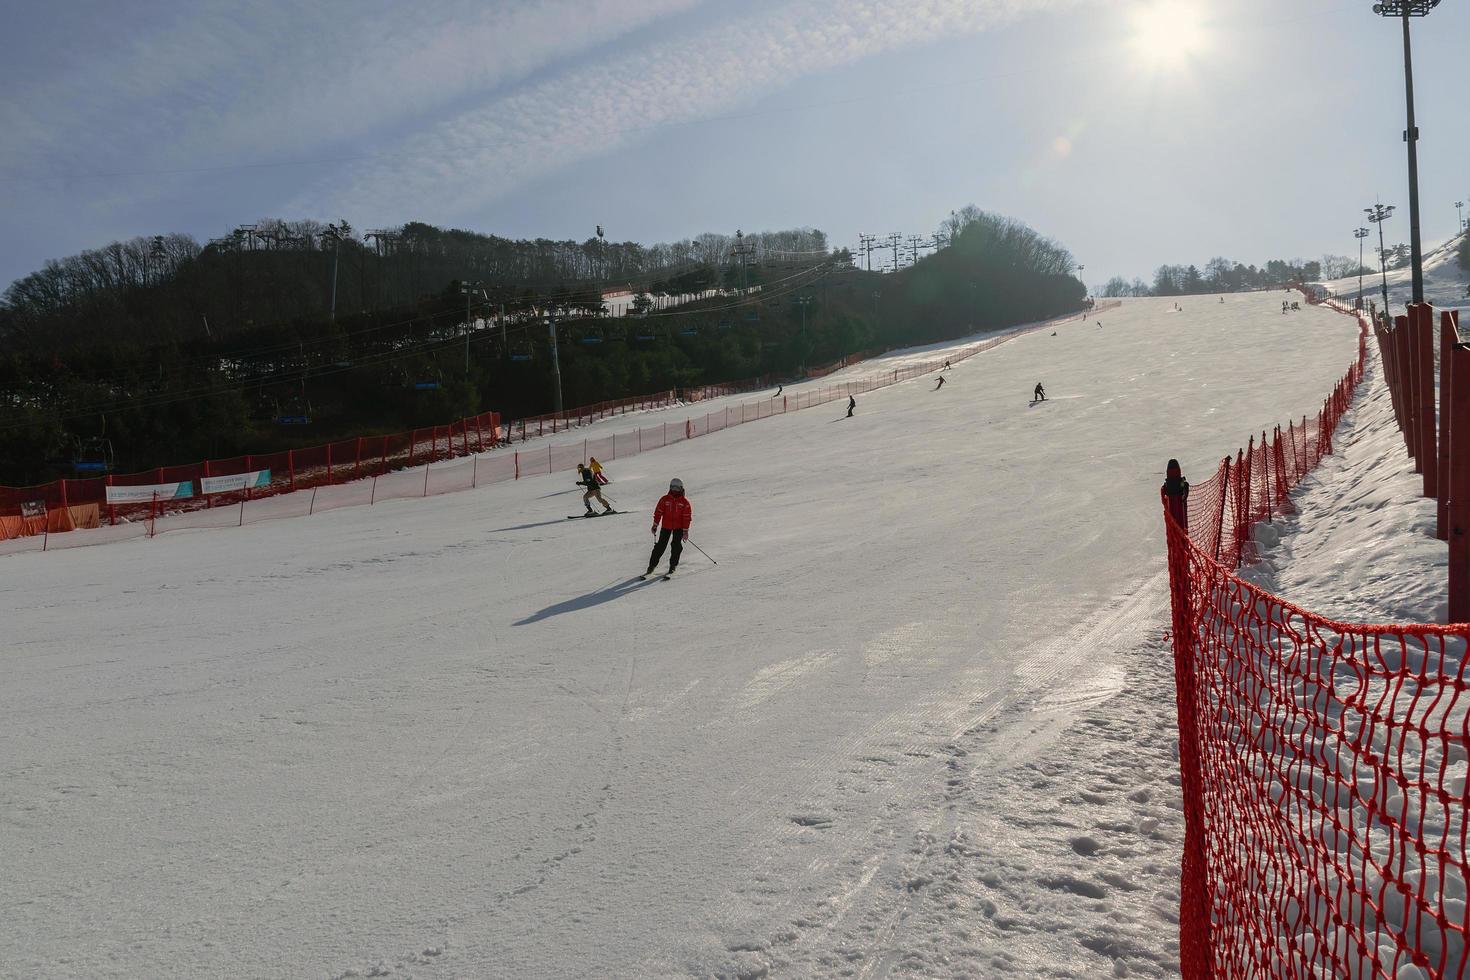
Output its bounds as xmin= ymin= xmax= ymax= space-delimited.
xmin=301 ymin=0 xmax=1069 ymax=220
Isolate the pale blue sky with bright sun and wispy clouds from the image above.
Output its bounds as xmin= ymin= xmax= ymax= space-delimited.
xmin=0 ymin=0 xmax=1470 ymax=295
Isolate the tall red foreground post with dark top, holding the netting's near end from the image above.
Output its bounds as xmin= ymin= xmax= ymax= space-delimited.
xmin=1164 ymin=457 xmax=1230 ymax=980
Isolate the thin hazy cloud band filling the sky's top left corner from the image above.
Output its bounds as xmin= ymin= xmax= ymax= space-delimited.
xmin=0 ymin=0 xmax=700 ymax=176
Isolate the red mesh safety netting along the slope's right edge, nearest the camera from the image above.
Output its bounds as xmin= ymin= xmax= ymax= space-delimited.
xmin=1164 ymin=295 xmax=1470 ymax=980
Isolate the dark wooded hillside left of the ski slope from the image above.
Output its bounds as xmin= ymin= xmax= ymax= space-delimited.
xmin=0 ymin=207 xmax=1086 ymax=485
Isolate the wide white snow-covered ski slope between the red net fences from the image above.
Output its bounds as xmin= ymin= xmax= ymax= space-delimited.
xmin=0 ymin=292 xmax=1357 ymax=979
